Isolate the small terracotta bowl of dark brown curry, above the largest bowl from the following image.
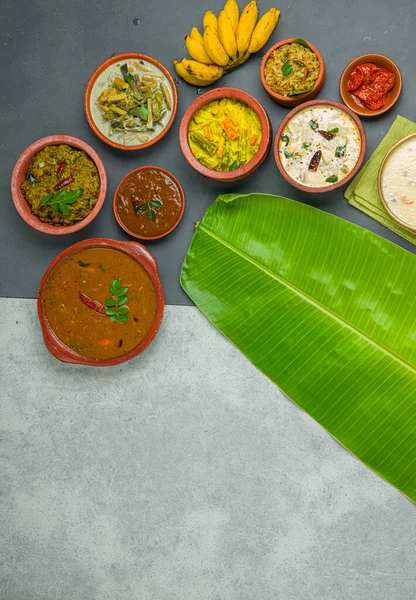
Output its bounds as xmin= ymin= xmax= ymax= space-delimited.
xmin=113 ymin=167 xmax=185 ymax=240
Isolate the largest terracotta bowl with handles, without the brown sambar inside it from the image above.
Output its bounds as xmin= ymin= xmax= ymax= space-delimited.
xmin=38 ymin=238 xmax=164 ymax=367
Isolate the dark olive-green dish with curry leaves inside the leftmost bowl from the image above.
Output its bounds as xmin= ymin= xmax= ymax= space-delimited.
xmin=20 ymin=144 xmax=100 ymax=227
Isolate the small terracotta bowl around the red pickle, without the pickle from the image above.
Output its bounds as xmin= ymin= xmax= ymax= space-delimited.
xmin=339 ymin=54 xmax=402 ymax=117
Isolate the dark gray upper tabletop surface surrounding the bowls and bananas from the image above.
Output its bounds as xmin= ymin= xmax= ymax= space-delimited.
xmin=0 ymin=0 xmax=416 ymax=304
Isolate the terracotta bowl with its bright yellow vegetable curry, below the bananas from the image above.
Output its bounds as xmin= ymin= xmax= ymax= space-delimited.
xmin=179 ymin=87 xmax=272 ymax=181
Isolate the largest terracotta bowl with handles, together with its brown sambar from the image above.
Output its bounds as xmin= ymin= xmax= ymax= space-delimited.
xmin=38 ymin=238 xmax=164 ymax=366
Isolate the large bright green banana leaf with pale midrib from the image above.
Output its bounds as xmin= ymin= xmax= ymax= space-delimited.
xmin=181 ymin=194 xmax=416 ymax=501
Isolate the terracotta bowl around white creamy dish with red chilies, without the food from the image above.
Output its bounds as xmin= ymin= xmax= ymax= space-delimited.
xmin=274 ymin=100 xmax=367 ymax=194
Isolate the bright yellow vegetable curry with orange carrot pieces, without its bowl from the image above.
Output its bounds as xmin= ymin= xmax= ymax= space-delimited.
xmin=188 ymin=98 xmax=262 ymax=171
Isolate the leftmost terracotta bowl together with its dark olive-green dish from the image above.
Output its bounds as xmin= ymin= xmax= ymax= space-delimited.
xmin=11 ymin=135 xmax=107 ymax=235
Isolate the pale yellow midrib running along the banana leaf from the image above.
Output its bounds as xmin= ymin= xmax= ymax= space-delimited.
xmin=196 ymin=223 xmax=416 ymax=374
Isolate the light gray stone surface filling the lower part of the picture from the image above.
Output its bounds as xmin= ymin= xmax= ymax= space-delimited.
xmin=0 ymin=299 xmax=416 ymax=600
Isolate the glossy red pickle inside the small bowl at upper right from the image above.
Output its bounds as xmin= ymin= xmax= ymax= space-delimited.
xmin=347 ymin=63 xmax=396 ymax=110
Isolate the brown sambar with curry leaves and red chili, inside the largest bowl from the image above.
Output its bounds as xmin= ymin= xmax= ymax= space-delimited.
xmin=43 ymin=248 xmax=157 ymax=360
